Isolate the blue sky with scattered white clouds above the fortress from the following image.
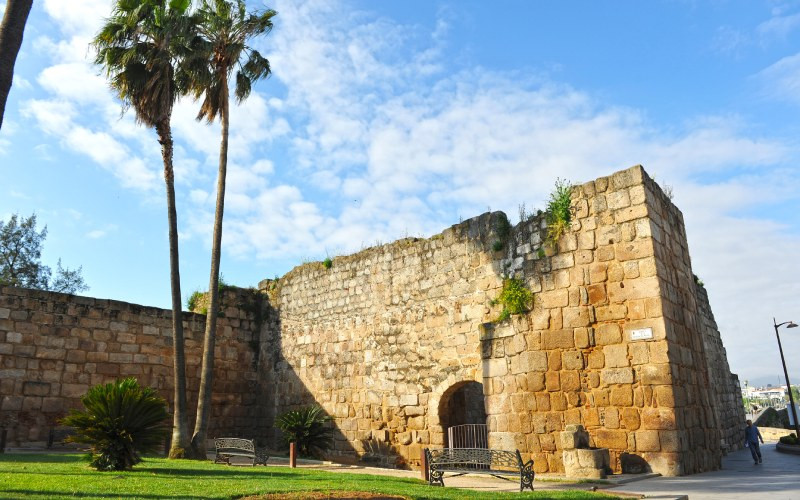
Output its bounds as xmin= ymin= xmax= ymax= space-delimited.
xmin=0 ymin=0 xmax=800 ymax=385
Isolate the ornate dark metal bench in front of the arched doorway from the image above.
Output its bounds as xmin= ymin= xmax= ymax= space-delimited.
xmin=425 ymin=448 xmax=534 ymax=491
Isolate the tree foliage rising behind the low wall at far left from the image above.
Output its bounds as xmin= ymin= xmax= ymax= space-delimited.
xmin=0 ymin=214 xmax=89 ymax=293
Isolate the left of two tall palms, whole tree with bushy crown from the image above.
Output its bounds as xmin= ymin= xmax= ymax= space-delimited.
xmin=93 ymin=0 xmax=199 ymax=458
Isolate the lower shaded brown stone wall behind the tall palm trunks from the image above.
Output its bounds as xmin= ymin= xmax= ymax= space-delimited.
xmin=0 ymin=287 xmax=265 ymax=447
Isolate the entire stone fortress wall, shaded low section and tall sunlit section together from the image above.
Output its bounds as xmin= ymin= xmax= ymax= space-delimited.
xmin=0 ymin=166 xmax=744 ymax=475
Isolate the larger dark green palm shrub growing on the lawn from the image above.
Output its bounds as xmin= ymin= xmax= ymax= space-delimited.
xmin=61 ymin=378 xmax=168 ymax=470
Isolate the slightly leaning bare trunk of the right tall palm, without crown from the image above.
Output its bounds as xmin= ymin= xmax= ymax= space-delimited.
xmin=192 ymin=72 xmax=228 ymax=458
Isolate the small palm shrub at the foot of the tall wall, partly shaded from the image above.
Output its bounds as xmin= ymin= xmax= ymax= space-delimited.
xmin=276 ymin=405 xmax=333 ymax=456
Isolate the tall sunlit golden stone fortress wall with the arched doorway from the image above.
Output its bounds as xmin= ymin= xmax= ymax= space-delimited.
xmin=262 ymin=166 xmax=743 ymax=475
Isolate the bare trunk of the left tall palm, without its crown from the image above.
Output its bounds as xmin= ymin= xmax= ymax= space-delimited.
xmin=156 ymin=119 xmax=190 ymax=458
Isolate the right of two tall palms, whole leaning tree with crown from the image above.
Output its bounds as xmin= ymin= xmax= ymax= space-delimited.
xmin=191 ymin=0 xmax=276 ymax=456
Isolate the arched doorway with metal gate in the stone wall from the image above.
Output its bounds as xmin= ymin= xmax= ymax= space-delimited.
xmin=439 ymin=380 xmax=487 ymax=448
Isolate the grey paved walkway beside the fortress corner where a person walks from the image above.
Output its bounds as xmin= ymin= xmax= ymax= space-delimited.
xmin=605 ymin=443 xmax=800 ymax=500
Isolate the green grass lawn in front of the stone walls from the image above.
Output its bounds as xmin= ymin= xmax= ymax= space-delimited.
xmin=0 ymin=453 xmax=614 ymax=500
